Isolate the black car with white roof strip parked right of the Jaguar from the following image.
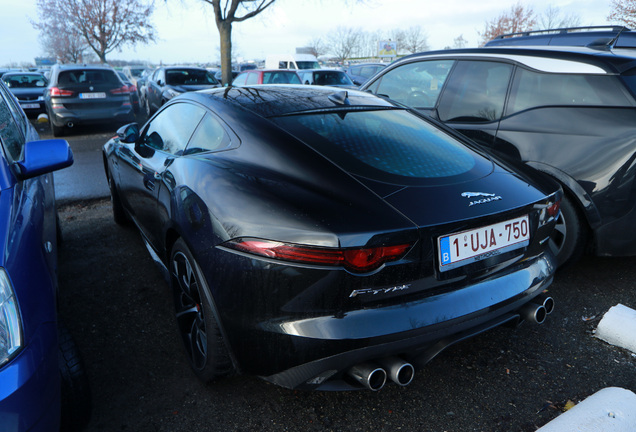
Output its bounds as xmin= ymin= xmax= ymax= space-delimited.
xmin=362 ymin=42 xmax=636 ymax=265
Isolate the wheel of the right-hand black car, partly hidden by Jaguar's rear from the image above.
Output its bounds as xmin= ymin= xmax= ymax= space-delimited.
xmin=548 ymin=195 xmax=587 ymax=269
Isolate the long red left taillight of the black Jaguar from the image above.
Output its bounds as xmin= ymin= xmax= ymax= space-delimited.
xmin=224 ymin=239 xmax=412 ymax=273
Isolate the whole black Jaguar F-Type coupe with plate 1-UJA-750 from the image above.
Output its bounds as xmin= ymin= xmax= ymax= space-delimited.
xmin=103 ymin=86 xmax=562 ymax=390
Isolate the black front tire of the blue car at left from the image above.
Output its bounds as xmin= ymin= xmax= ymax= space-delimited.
xmin=58 ymin=324 xmax=92 ymax=432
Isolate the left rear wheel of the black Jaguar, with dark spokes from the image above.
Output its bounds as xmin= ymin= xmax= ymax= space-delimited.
xmin=169 ymin=239 xmax=233 ymax=382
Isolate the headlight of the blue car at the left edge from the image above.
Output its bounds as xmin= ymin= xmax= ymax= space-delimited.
xmin=0 ymin=268 xmax=22 ymax=366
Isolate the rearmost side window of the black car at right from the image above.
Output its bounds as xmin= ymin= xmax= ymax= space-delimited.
xmin=506 ymin=68 xmax=634 ymax=115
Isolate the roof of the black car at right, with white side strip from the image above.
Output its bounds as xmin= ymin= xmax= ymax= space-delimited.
xmin=390 ymin=46 xmax=636 ymax=74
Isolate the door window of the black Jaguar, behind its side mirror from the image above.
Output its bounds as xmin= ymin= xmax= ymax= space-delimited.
xmin=143 ymin=103 xmax=205 ymax=156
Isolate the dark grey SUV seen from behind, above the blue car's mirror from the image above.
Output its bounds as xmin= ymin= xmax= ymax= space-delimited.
xmin=44 ymin=65 xmax=135 ymax=136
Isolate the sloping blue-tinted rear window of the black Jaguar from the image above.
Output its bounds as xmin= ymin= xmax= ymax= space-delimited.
xmin=272 ymin=110 xmax=492 ymax=185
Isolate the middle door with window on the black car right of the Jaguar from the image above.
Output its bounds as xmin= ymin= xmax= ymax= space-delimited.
xmin=435 ymin=60 xmax=514 ymax=148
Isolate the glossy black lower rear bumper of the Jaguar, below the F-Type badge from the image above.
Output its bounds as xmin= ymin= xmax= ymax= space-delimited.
xmin=225 ymin=254 xmax=555 ymax=390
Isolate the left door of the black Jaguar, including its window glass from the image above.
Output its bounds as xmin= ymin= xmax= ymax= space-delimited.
xmin=117 ymin=102 xmax=205 ymax=245
